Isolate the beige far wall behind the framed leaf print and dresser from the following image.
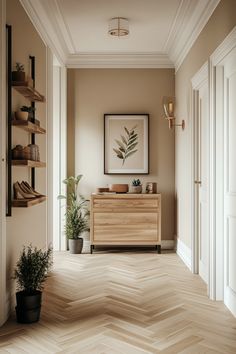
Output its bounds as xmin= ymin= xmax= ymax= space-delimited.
xmin=68 ymin=69 xmax=175 ymax=239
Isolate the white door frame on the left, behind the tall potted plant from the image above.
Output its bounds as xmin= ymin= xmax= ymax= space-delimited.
xmin=47 ymin=47 xmax=67 ymax=251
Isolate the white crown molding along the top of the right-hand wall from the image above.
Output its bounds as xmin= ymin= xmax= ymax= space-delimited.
xmin=169 ymin=0 xmax=220 ymax=71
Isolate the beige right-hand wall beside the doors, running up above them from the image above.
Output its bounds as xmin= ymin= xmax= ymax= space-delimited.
xmin=175 ymin=0 xmax=236 ymax=247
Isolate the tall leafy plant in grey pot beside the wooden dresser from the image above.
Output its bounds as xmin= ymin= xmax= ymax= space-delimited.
xmin=58 ymin=175 xmax=89 ymax=254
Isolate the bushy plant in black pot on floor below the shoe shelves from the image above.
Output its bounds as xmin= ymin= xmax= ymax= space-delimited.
xmin=14 ymin=245 xmax=52 ymax=323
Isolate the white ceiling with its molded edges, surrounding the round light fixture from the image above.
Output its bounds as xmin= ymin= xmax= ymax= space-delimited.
xmin=21 ymin=0 xmax=219 ymax=68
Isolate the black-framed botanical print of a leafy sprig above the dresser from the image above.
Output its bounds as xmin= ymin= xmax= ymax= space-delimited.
xmin=104 ymin=114 xmax=149 ymax=175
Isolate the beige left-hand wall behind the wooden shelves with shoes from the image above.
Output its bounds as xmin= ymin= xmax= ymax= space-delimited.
xmin=7 ymin=0 xmax=46 ymax=300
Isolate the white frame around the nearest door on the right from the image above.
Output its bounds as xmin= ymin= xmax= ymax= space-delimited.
xmin=209 ymin=26 xmax=236 ymax=300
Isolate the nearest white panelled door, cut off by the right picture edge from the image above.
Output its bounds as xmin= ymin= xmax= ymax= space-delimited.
xmin=223 ymin=48 xmax=236 ymax=316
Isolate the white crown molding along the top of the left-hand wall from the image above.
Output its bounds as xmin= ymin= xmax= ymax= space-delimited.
xmin=20 ymin=0 xmax=69 ymax=64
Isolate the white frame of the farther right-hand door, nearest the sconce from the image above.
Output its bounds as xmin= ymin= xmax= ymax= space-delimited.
xmin=191 ymin=62 xmax=209 ymax=278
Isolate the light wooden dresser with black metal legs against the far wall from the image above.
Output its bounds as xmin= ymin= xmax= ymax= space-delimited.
xmin=90 ymin=194 xmax=161 ymax=253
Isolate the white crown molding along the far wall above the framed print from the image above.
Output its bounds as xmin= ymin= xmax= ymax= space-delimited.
xmin=66 ymin=53 xmax=174 ymax=68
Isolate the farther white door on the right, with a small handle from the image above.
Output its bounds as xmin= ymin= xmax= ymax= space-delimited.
xmin=192 ymin=64 xmax=209 ymax=284
